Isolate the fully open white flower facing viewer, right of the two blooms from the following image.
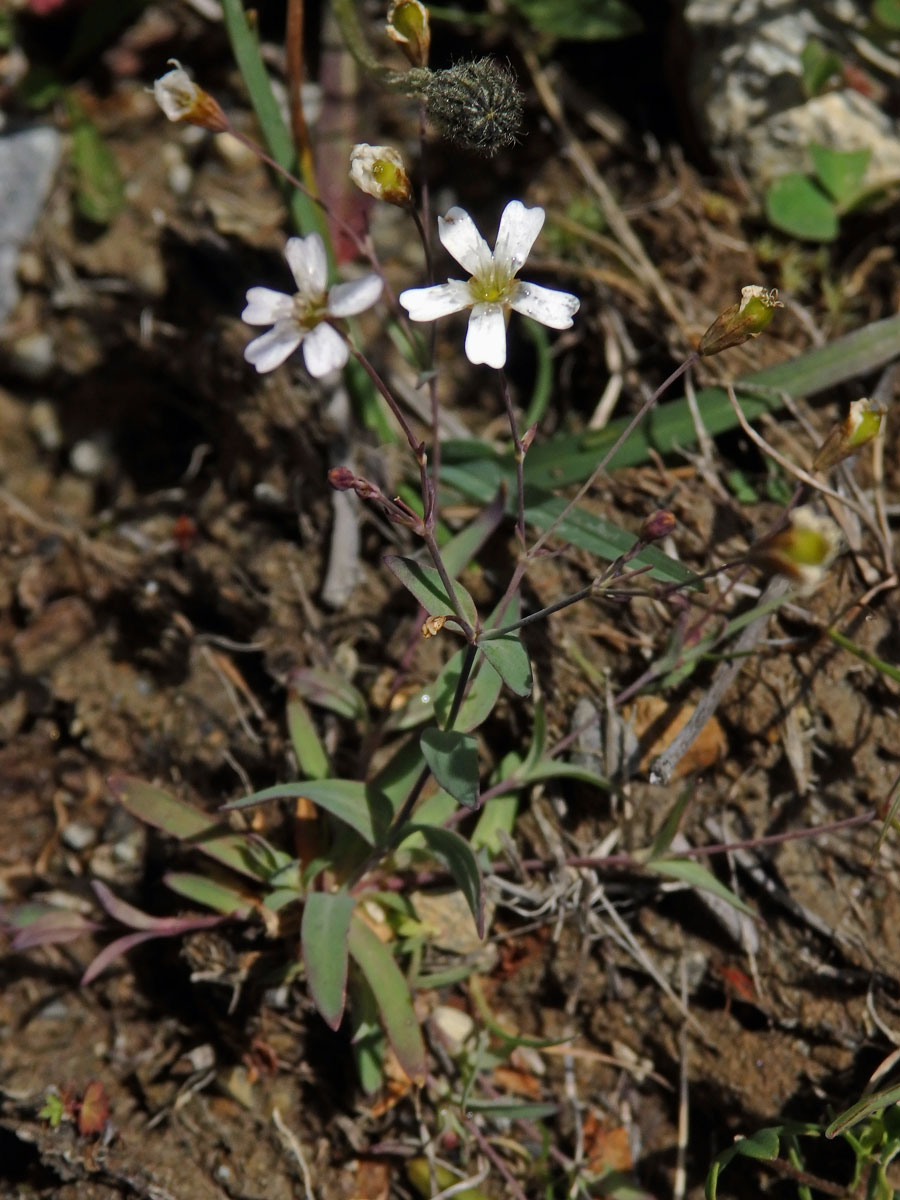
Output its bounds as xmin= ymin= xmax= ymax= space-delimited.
xmin=400 ymin=200 xmax=581 ymax=370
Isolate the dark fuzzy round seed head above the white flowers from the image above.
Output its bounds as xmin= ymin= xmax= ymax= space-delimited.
xmin=420 ymin=59 xmax=522 ymax=155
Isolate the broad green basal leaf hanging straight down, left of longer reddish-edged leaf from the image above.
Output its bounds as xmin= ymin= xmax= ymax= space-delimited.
xmin=300 ymin=890 xmax=356 ymax=1030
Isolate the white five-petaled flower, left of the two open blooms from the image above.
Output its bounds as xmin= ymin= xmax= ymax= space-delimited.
xmin=241 ymin=233 xmax=382 ymax=379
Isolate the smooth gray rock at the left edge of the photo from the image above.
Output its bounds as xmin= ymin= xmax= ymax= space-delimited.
xmin=0 ymin=125 xmax=62 ymax=324
